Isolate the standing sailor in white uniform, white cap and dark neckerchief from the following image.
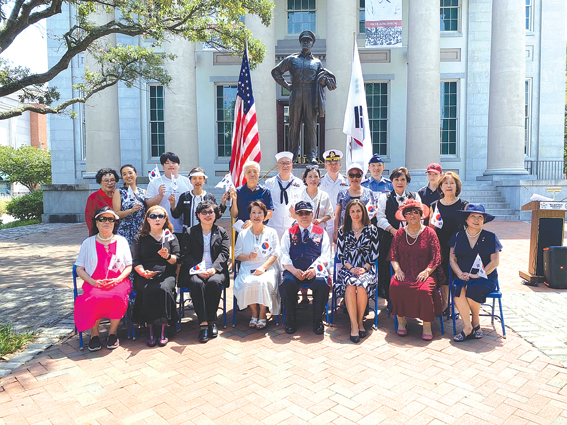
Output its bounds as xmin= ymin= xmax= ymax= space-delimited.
xmin=266 ymin=151 xmax=305 ymax=239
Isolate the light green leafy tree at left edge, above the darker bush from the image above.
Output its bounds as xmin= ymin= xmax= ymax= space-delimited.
xmin=0 ymin=146 xmax=51 ymax=192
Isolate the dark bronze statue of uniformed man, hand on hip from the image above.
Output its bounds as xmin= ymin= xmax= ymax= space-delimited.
xmin=272 ymin=30 xmax=337 ymax=164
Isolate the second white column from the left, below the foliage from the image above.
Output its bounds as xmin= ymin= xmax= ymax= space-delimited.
xmin=164 ymin=37 xmax=199 ymax=174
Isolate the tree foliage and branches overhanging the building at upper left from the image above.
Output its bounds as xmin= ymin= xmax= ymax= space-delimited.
xmin=0 ymin=0 xmax=274 ymax=119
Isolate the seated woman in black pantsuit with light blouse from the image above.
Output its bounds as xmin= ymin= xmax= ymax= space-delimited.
xmin=179 ymin=201 xmax=230 ymax=342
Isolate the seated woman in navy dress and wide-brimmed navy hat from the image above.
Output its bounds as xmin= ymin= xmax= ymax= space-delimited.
xmin=449 ymin=204 xmax=502 ymax=342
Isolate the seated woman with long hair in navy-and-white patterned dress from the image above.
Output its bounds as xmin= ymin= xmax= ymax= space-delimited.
xmin=336 ymin=199 xmax=378 ymax=343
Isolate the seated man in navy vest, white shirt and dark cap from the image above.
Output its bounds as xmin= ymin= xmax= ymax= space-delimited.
xmin=280 ymin=201 xmax=330 ymax=335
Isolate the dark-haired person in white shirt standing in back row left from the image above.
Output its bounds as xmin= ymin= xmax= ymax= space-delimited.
xmin=146 ymin=152 xmax=193 ymax=235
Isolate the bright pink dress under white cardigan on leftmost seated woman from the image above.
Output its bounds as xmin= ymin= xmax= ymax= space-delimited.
xmin=75 ymin=242 xmax=130 ymax=332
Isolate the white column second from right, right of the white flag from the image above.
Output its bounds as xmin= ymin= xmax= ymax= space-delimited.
xmin=406 ymin=0 xmax=441 ymax=172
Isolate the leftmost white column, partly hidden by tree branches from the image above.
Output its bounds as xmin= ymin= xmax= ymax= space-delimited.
xmin=85 ymin=9 xmax=120 ymax=175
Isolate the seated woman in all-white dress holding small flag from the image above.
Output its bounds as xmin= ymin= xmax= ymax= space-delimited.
xmin=234 ymin=201 xmax=281 ymax=329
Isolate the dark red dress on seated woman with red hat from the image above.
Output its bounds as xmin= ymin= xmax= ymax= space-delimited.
xmin=388 ymin=227 xmax=442 ymax=322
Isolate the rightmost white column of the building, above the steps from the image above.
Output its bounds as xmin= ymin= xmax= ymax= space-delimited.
xmin=484 ymin=0 xmax=527 ymax=175
